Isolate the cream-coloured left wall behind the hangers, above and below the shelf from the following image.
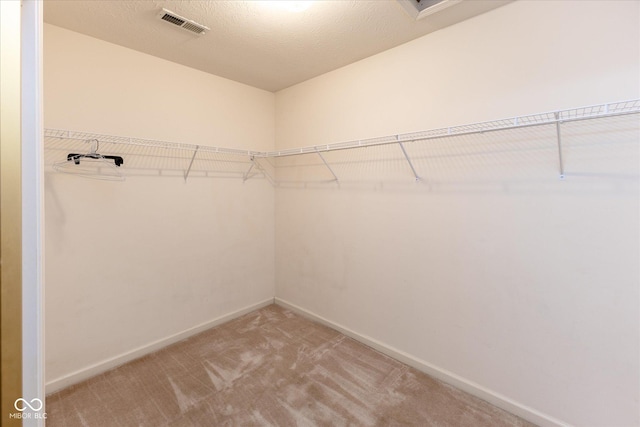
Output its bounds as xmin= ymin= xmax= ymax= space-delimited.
xmin=44 ymin=25 xmax=275 ymax=392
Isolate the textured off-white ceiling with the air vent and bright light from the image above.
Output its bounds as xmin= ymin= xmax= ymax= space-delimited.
xmin=44 ymin=0 xmax=509 ymax=92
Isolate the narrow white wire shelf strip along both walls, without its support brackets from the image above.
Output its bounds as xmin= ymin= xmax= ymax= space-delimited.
xmin=44 ymin=99 xmax=640 ymax=162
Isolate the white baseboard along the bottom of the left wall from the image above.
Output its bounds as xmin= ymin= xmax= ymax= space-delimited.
xmin=45 ymin=298 xmax=274 ymax=394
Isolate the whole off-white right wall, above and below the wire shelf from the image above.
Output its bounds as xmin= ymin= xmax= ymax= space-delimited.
xmin=276 ymin=1 xmax=640 ymax=426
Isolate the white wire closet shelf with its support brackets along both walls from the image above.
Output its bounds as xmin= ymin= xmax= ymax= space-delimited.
xmin=44 ymin=99 xmax=640 ymax=185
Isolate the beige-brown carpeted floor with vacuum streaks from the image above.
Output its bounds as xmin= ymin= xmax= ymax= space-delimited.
xmin=46 ymin=305 xmax=531 ymax=427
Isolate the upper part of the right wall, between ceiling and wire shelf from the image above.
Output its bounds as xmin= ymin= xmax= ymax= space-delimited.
xmin=276 ymin=0 xmax=639 ymax=148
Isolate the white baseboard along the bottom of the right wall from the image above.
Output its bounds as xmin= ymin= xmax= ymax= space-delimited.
xmin=275 ymin=298 xmax=569 ymax=427
